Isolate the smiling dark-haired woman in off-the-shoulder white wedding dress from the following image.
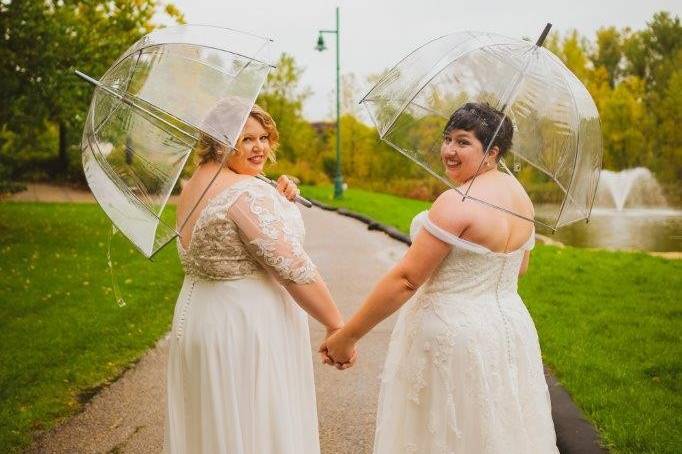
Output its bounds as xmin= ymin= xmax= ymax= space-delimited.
xmin=320 ymin=103 xmax=558 ymax=454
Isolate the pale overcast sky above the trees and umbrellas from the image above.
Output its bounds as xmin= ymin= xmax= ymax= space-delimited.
xmin=166 ymin=0 xmax=682 ymax=120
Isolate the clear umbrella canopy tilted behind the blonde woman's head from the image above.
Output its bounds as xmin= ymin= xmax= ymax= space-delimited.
xmin=79 ymin=25 xmax=272 ymax=257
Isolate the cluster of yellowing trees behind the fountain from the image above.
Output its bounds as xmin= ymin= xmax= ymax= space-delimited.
xmin=547 ymin=12 xmax=682 ymax=191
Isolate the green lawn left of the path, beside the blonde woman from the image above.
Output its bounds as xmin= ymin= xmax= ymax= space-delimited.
xmin=0 ymin=203 xmax=182 ymax=452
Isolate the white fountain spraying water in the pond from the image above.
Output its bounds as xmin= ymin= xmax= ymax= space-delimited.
xmin=595 ymin=167 xmax=668 ymax=211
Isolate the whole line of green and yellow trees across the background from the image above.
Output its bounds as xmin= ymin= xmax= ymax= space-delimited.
xmin=0 ymin=0 xmax=682 ymax=200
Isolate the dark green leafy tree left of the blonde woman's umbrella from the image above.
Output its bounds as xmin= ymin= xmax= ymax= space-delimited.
xmin=0 ymin=0 xmax=183 ymax=181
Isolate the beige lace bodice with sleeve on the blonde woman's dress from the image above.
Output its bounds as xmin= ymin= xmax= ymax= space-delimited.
xmin=178 ymin=178 xmax=316 ymax=284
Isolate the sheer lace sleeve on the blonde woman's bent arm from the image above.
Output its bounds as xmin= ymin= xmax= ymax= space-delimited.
xmin=228 ymin=191 xmax=317 ymax=284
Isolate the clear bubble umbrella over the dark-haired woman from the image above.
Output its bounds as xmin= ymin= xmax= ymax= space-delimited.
xmin=361 ymin=24 xmax=602 ymax=231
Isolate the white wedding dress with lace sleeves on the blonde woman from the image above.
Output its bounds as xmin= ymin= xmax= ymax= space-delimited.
xmin=164 ymin=178 xmax=319 ymax=454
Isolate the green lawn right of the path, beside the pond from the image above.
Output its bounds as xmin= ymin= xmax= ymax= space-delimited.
xmin=302 ymin=187 xmax=682 ymax=454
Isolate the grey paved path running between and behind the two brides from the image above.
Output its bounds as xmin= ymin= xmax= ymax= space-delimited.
xmin=15 ymin=187 xmax=599 ymax=454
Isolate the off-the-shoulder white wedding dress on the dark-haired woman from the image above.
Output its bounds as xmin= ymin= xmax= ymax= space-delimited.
xmin=374 ymin=212 xmax=558 ymax=454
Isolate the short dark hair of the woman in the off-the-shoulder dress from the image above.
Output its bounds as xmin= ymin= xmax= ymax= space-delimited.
xmin=443 ymin=102 xmax=514 ymax=159
